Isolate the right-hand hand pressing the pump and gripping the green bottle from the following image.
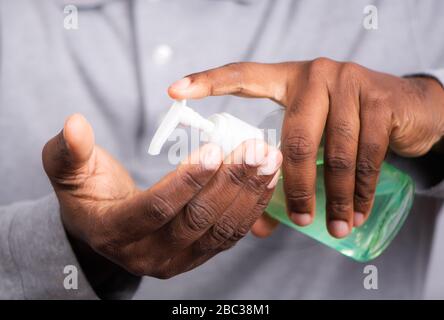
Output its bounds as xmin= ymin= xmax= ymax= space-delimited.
xmin=169 ymin=58 xmax=444 ymax=238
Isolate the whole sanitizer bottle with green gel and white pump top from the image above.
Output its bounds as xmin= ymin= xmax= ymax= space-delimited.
xmin=148 ymin=101 xmax=414 ymax=262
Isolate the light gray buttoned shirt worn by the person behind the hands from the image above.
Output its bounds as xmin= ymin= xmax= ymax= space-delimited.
xmin=0 ymin=0 xmax=444 ymax=299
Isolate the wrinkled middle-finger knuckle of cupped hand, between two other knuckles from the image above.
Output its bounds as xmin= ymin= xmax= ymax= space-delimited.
xmin=185 ymin=200 xmax=217 ymax=231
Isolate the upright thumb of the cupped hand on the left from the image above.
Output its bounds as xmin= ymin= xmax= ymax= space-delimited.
xmin=42 ymin=114 xmax=94 ymax=184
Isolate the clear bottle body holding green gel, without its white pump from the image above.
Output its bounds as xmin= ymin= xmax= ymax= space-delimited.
xmin=260 ymin=110 xmax=414 ymax=262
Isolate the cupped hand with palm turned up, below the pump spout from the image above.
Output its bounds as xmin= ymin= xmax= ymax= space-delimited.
xmin=42 ymin=114 xmax=282 ymax=278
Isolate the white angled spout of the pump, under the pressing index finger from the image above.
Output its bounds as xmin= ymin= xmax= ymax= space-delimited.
xmin=148 ymin=100 xmax=214 ymax=156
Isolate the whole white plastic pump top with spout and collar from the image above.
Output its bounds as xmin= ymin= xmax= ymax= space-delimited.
xmin=148 ymin=100 xmax=264 ymax=155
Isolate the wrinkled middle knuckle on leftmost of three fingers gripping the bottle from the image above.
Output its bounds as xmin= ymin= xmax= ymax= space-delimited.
xmin=282 ymin=132 xmax=316 ymax=163
